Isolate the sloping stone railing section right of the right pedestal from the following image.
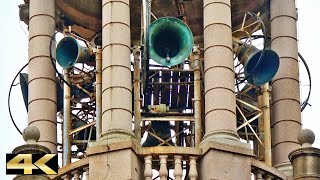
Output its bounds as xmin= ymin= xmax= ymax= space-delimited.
xmin=251 ymin=159 xmax=288 ymax=180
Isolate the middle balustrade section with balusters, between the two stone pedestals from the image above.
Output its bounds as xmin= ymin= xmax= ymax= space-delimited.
xmin=139 ymin=146 xmax=201 ymax=180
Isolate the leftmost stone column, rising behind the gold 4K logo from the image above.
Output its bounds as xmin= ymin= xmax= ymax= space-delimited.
xmin=28 ymin=0 xmax=57 ymax=153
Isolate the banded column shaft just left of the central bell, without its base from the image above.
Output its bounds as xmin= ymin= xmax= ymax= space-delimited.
xmin=102 ymin=0 xmax=133 ymax=143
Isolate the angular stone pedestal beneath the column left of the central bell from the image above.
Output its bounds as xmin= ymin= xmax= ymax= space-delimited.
xmin=87 ymin=141 xmax=143 ymax=180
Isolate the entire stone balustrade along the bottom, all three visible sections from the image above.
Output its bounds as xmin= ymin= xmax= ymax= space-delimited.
xmin=49 ymin=146 xmax=288 ymax=180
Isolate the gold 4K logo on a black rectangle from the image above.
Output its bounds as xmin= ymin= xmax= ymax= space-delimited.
xmin=6 ymin=154 xmax=58 ymax=175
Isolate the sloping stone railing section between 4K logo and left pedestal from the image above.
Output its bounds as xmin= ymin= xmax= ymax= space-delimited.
xmin=49 ymin=158 xmax=89 ymax=180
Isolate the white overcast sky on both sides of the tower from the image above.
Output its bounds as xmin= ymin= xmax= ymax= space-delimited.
xmin=0 ymin=0 xmax=320 ymax=180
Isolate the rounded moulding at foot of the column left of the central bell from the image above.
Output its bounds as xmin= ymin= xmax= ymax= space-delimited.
xmin=89 ymin=129 xmax=139 ymax=147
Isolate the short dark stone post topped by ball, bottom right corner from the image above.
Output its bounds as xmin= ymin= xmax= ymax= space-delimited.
xmin=289 ymin=129 xmax=320 ymax=180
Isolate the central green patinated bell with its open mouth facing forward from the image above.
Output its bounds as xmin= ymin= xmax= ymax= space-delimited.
xmin=149 ymin=17 xmax=193 ymax=66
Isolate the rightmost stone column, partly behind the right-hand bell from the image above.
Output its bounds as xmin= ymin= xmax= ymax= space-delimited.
xmin=270 ymin=0 xmax=301 ymax=176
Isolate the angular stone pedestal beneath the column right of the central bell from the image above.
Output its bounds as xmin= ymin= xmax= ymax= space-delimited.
xmin=198 ymin=141 xmax=253 ymax=179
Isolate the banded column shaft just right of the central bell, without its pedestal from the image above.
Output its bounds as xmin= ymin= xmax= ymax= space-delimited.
xmin=203 ymin=0 xmax=238 ymax=141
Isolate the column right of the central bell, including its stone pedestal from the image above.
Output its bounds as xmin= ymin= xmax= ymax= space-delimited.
xmin=198 ymin=0 xmax=253 ymax=179
